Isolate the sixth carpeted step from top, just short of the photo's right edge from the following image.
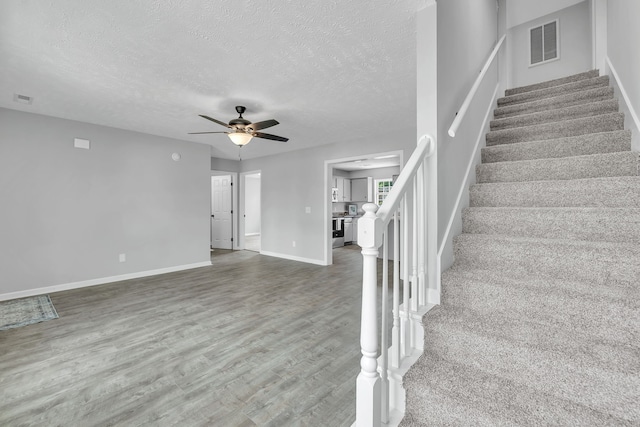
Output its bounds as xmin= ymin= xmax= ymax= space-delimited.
xmin=482 ymin=130 xmax=631 ymax=163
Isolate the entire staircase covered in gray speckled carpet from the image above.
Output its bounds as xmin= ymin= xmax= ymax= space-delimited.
xmin=401 ymin=71 xmax=640 ymax=426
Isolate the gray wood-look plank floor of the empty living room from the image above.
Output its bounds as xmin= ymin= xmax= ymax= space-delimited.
xmin=0 ymin=248 xmax=384 ymax=426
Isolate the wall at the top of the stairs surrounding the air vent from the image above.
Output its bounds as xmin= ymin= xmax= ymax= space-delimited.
xmin=507 ymin=1 xmax=593 ymax=87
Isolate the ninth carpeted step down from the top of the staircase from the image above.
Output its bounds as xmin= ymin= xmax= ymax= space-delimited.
xmin=462 ymin=208 xmax=640 ymax=243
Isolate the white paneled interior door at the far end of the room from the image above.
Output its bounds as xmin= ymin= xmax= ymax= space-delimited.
xmin=211 ymin=175 xmax=233 ymax=249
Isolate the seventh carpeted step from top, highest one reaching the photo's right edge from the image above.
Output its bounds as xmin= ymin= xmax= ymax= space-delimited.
xmin=476 ymin=151 xmax=639 ymax=183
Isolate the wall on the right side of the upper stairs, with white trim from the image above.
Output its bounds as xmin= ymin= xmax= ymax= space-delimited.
xmin=607 ymin=0 xmax=640 ymax=151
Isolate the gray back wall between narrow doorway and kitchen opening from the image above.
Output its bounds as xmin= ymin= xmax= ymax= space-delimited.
xmin=235 ymin=132 xmax=416 ymax=263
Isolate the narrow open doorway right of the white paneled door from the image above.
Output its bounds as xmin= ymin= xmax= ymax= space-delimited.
xmin=242 ymin=171 xmax=262 ymax=252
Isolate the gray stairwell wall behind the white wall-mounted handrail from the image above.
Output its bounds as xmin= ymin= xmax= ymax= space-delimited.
xmin=437 ymin=0 xmax=498 ymax=271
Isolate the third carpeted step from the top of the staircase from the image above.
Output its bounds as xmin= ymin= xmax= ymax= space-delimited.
xmin=493 ymin=86 xmax=613 ymax=119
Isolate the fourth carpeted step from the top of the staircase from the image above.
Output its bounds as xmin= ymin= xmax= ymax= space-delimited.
xmin=490 ymin=99 xmax=618 ymax=130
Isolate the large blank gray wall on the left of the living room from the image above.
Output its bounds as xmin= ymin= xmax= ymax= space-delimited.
xmin=0 ymin=109 xmax=210 ymax=294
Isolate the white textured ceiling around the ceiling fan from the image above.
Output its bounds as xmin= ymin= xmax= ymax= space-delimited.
xmin=0 ymin=0 xmax=420 ymax=159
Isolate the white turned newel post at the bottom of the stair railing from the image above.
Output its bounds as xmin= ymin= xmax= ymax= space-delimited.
xmin=356 ymin=203 xmax=382 ymax=427
